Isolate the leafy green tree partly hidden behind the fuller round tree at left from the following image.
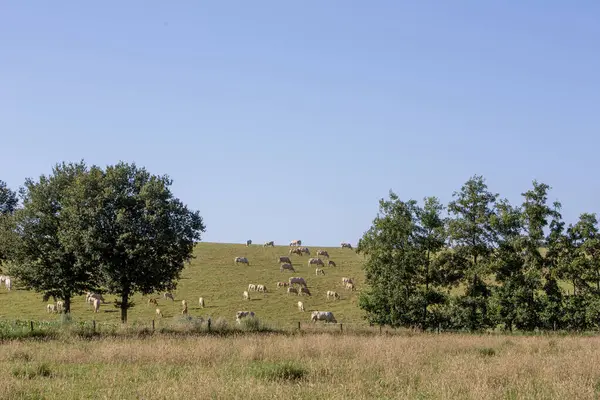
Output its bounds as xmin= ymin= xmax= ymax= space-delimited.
xmin=9 ymin=162 xmax=97 ymax=313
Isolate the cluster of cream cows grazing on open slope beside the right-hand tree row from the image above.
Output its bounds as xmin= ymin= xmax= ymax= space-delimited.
xmin=231 ymin=240 xmax=355 ymax=324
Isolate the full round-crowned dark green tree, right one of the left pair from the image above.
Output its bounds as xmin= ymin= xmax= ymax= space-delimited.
xmin=63 ymin=163 xmax=205 ymax=322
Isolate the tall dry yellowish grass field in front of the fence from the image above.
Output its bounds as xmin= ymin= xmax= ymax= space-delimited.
xmin=0 ymin=334 xmax=600 ymax=400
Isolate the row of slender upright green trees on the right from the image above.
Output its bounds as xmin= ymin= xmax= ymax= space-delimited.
xmin=357 ymin=175 xmax=600 ymax=331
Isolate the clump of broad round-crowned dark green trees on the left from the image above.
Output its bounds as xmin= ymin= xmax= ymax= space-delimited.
xmin=0 ymin=161 xmax=205 ymax=322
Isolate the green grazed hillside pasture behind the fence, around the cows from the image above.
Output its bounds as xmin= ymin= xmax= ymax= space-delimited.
xmin=0 ymin=243 xmax=365 ymax=327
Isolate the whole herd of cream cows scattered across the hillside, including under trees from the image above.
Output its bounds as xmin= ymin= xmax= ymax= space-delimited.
xmin=0 ymin=240 xmax=356 ymax=324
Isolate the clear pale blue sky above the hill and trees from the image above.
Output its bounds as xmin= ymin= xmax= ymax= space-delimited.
xmin=0 ymin=0 xmax=600 ymax=246
